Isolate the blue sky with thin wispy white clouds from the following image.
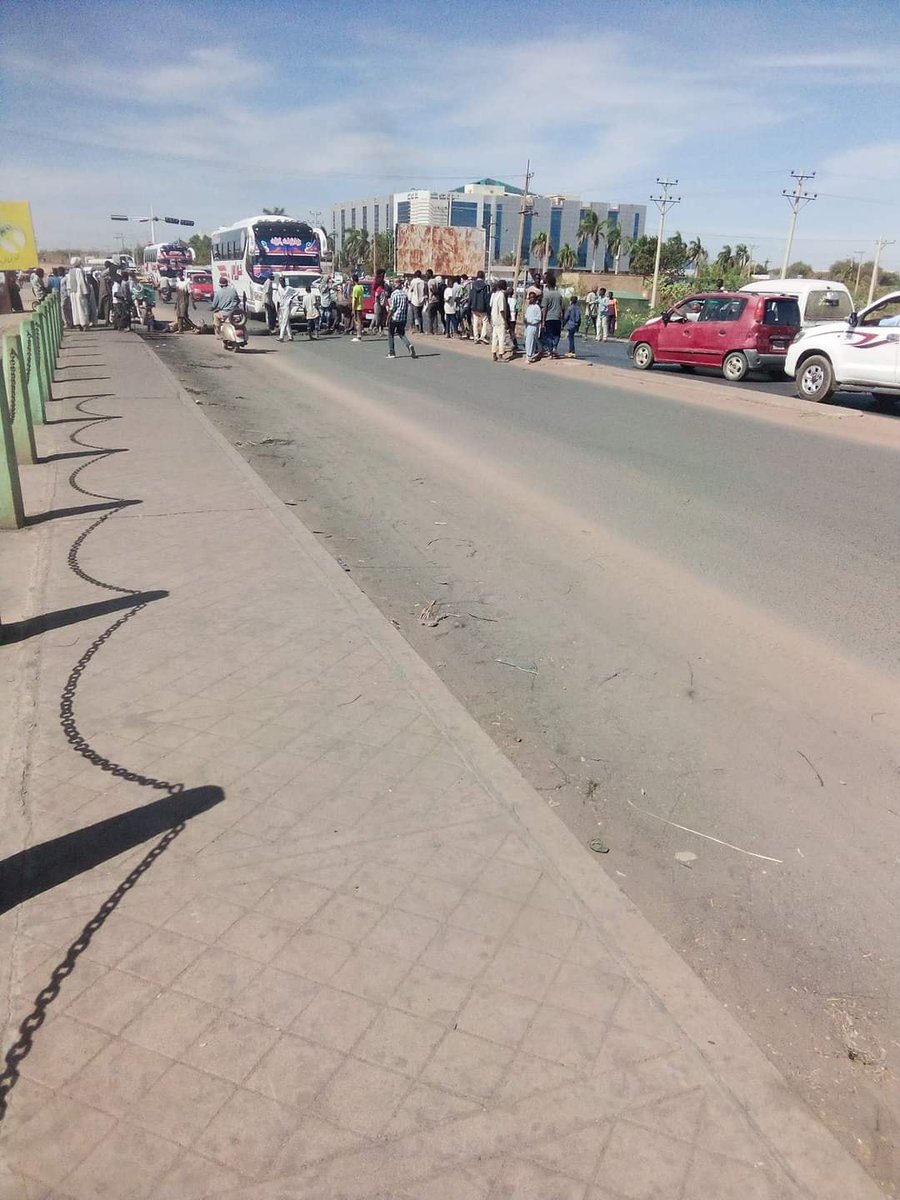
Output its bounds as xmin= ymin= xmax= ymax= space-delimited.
xmin=0 ymin=0 xmax=900 ymax=269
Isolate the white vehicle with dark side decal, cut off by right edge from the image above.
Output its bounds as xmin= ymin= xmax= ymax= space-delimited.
xmin=785 ymin=292 xmax=900 ymax=401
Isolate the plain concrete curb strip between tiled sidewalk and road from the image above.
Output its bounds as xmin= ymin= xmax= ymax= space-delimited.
xmin=133 ymin=340 xmax=883 ymax=1200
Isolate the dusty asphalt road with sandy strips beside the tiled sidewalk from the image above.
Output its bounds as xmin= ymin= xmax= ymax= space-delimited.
xmin=146 ymin=314 xmax=900 ymax=1195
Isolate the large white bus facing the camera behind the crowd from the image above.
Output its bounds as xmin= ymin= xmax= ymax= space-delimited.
xmin=210 ymin=215 xmax=328 ymax=316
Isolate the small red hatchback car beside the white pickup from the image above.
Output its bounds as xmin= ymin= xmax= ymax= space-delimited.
xmin=629 ymin=292 xmax=800 ymax=383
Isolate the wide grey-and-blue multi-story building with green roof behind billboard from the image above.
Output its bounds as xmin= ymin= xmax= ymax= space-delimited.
xmin=331 ymin=179 xmax=647 ymax=270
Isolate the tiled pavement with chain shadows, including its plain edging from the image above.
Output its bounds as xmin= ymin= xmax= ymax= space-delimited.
xmin=0 ymin=331 xmax=881 ymax=1200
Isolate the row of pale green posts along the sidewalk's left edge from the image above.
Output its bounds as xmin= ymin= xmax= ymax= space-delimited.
xmin=0 ymin=292 xmax=62 ymax=529
